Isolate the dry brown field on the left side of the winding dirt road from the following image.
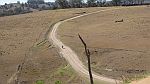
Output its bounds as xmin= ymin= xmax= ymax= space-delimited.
xmin=0 ymin=8 xmax=109 ymax=84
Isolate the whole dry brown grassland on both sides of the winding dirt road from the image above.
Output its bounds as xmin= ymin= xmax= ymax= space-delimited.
xmin=0 ymin=6 xmax=150 ymax=84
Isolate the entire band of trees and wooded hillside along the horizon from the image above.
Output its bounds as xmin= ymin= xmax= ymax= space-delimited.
xmin=0 ymin=0 xmax=148 ymax=16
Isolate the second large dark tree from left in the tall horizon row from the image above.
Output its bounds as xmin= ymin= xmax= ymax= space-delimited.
xmin=69 ymin=0 xmax=83 ymax=8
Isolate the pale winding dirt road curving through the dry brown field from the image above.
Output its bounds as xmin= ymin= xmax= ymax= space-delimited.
xmin=48 ymin=8 xmax=121 ymax=84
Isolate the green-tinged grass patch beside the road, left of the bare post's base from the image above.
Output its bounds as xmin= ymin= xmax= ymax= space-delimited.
xmin=48 ymin=65 xmax=87 ymax=84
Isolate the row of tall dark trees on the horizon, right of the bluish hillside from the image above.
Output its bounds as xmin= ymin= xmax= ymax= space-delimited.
xmin=55 ymin=0 xmax=145 ymax=8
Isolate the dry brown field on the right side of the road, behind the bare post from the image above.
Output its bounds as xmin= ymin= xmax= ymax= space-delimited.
xmin=58 ymin=6 xmax=150 ymax=80
